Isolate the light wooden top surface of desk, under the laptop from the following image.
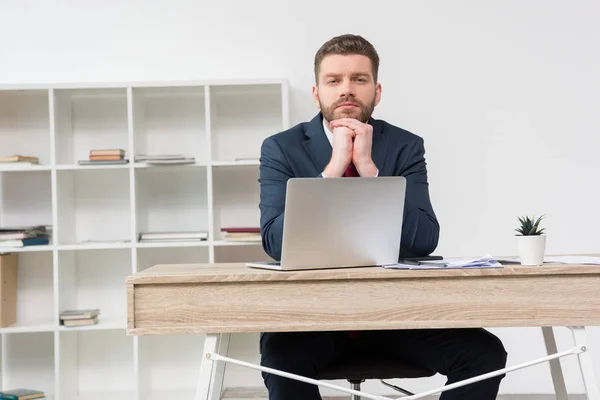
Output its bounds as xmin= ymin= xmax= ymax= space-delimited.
xmin=127 ymin=255 xmax=600 ymax=284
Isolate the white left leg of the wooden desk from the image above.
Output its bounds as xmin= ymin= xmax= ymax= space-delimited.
xmin=195 ymin=334 xmax=230 ymax=400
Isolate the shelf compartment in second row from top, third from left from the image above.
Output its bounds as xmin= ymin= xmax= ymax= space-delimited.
xmin=136 ymin=167 xmax=208 ymax=239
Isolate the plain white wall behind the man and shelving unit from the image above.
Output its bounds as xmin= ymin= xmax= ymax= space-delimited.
xmin=0 ymin=0 xmax=600 ymax=393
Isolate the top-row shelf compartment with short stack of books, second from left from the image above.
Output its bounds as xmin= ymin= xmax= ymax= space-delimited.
xmin=54 ymin=88 xmax=129 ymax=164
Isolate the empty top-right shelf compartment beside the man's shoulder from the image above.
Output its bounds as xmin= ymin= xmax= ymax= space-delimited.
xmin=210 ymin=84 xmax=284 ymax=162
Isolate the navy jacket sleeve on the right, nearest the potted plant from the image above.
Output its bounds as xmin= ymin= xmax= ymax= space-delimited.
xmin=398 ymin=137 xmax=440 ymax=257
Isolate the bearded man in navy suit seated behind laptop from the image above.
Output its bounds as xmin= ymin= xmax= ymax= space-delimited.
xmin=259 ymin=35 xmax=507 ymax=400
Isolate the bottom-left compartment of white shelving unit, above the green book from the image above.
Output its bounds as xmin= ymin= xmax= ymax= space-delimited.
xmin=2 ymin=333 xmax=55 ymax=396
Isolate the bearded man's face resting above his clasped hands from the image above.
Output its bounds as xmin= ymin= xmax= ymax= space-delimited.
xmin=312 ymin=54 xmax=381 ymax=122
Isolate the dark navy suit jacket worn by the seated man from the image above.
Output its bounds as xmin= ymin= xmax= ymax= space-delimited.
xmin=259 ymin=113 xmax=440 ymax=261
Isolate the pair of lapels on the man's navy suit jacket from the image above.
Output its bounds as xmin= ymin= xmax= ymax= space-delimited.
xmin=302 ymin=113 xmax=387 ymax=175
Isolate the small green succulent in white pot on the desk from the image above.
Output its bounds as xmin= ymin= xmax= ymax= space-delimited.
xmin=515 ymin=215 xmax=546 ymax=265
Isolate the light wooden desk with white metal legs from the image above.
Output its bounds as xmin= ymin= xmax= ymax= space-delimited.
xmin=126 ymin=263 xmax=600 ymax=399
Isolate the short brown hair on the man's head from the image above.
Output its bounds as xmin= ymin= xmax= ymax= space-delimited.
xmin=315 ymin=34 xmax=379 ymax=83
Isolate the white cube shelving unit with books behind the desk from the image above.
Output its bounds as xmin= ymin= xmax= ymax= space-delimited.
xmin=0 ymin=80 xmax=289 ymax=400
